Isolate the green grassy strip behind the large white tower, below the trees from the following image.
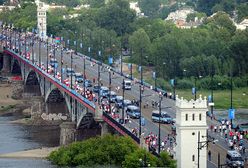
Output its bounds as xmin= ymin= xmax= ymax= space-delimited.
xmin=176 ymin=87 xmax=248 ymax=109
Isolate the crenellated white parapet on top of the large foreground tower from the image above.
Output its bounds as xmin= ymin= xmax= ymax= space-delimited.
xmin=176 ymin=95 xmax=207 ymax=108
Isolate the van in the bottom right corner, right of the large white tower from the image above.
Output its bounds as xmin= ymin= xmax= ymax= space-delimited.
xmin=226 ymin=150 xmax=244 ymax=168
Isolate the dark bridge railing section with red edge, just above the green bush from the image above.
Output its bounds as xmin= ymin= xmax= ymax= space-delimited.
xmin=103 ymin=112 xmax=140 ymax=144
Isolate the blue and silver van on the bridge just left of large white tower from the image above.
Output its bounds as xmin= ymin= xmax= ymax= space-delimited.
xmin=152 ymin=110 xmax=173 ymax=124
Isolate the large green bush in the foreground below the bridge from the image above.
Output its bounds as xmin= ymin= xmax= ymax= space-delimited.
xmin=48 ymin=135 xmax=174 ymax=167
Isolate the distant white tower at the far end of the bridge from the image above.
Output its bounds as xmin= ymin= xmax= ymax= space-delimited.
xmin=36 ymin=1 xmax=47 ymax=39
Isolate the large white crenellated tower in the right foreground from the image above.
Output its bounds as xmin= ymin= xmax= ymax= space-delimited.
xmin=176 ymin=96 xmax=207 ymax=168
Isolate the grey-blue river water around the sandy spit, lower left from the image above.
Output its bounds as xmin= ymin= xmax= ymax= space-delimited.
xmin=0 ymin=112 xmax=59 ymax=168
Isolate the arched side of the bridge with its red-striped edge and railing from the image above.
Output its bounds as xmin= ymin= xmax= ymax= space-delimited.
xmin=1 ymin=28 xmax=139 ymax=144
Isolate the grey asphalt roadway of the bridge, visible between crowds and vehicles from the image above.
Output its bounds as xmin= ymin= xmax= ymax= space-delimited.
xmin=3 ymin=31 xmax=247 ymax=165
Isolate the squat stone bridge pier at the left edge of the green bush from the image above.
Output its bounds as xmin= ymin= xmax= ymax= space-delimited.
xmin=60 ymin=122 xmax=76 ymax=145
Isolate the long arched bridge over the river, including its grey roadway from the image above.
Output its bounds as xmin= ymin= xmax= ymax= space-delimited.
xmin=1 ymin=26 xmax=247 ymax=167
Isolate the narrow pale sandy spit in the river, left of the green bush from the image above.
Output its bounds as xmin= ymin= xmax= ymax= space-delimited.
xmin=0 ymin=147 xmax=58 ymax=159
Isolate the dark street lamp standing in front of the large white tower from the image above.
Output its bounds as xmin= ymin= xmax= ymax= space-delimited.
xmin=197 ymin=131 xmax=218 ymax=168
